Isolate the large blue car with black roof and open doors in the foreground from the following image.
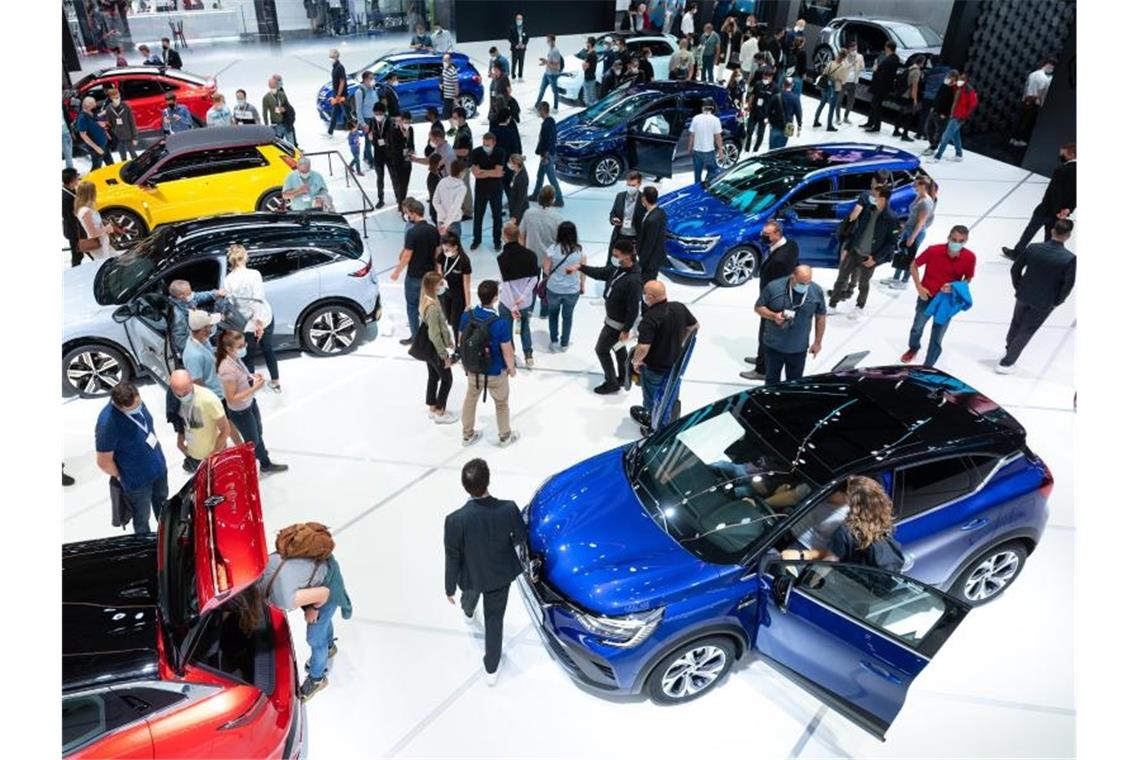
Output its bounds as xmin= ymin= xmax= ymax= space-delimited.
xmin=520 ymin=367 xmax=1052 ymax=738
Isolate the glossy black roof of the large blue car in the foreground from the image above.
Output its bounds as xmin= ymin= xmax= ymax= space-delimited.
xmin=750 ymin=366 xmax=1025 ymax=483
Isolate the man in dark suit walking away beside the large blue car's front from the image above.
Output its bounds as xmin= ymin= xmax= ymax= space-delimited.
xmin=443 ymin=459 xmax=527 ymax=686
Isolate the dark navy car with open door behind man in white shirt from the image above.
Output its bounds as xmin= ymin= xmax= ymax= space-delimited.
xmin=554 ymin=82 xmax=744 ymax=187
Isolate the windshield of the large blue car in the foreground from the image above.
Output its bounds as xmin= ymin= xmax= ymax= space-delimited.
xmin=626 ymin=392 xmax=816 ymax=564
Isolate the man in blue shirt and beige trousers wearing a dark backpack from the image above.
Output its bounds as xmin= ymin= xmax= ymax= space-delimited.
xmin=459 ymin=280 xmax=519 ymax=447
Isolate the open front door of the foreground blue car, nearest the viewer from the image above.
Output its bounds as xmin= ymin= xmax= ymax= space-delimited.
xmin=754 ymin=562 xmax=969 ymax=739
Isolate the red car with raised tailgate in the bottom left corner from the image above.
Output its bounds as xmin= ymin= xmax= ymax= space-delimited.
xmin=63 ymin=443 xmax=308 ymax=758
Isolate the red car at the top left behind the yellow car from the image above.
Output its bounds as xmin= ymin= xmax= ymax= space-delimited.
xmin=65 ymin=66 xmax=218 ymax=132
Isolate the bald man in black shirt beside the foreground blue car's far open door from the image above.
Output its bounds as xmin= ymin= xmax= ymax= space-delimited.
xmin=629 ymin=280 xmax=700 ymax=434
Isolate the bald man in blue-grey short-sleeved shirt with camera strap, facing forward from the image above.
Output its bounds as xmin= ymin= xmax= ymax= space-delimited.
xmin=756 ymin=264 xmax=828 ymax=385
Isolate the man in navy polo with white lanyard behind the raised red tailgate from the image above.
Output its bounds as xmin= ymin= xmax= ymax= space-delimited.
xmin=95 ymin=382 xmax=168 ymax=533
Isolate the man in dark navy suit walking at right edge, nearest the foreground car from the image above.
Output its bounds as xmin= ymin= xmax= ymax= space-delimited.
xmin=994 ymin=219 xmax=1076 ymax=375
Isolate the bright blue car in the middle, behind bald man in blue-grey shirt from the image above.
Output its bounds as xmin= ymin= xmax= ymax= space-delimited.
xmin=660 ymin=142 xmax=923 ymax=286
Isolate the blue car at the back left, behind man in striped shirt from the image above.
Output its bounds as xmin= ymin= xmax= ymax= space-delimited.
xmin=317 ymin=50 xmax=483 ymax=128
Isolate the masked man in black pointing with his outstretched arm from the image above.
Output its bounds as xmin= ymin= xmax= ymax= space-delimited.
xmin=565 ymin=239 xmax=642 ymax=395
